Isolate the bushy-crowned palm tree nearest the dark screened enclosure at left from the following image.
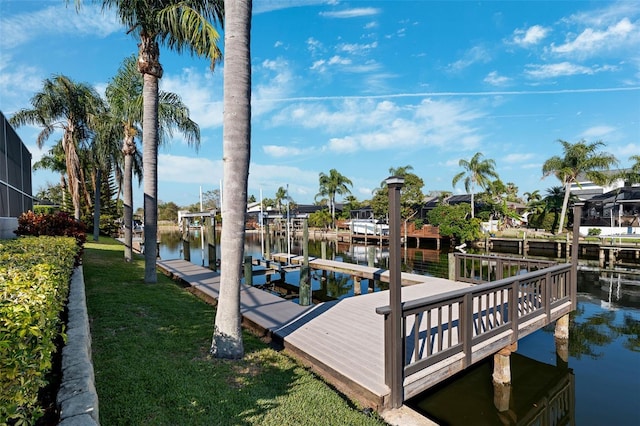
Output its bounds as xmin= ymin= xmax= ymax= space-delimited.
xmin=9 ymin=75 xmax=102 ymax=220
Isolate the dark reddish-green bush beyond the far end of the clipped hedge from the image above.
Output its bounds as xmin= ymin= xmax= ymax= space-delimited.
xmin=14 ymin=211 xmax=87 ymax=264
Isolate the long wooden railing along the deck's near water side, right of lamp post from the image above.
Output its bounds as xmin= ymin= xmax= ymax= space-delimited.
xmin=376 ymin=257 xmax=576 ymax=399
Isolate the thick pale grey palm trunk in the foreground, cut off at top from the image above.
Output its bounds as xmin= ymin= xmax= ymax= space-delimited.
xmin=211 ymin=0 xmax=252 ymax=359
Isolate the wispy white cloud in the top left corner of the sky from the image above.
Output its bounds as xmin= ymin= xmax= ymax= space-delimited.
xmin=0 ymin=4 xmax=124 ymax=50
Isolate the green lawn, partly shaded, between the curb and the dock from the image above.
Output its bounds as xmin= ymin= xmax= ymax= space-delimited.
xmin=83 ymin=238 xmax=385 ymax=426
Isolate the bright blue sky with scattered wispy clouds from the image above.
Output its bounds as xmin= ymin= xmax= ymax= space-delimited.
xmin=0 ymin=0 xmax=640 ymax=207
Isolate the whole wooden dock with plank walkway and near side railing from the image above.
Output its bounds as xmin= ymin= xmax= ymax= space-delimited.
xmin=158 ymin=255 xmax=575 ymax=411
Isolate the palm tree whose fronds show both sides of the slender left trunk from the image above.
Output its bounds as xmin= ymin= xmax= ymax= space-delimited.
xmin=106 ymin=56 xmax=200 ymax=262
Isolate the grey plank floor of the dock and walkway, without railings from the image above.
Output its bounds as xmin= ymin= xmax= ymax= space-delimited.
xmin=158 ymin=260 xmax=471 ymax=410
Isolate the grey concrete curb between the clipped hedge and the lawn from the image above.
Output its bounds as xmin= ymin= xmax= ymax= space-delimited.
xmin=57 ymin=265 xmax=100 ymax=426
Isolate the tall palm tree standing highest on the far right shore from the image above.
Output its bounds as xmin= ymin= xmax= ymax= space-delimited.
xmin=542 ymin=140 xmax=617 ymax=233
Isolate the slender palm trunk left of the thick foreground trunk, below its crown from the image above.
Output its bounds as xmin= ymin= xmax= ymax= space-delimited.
xmin=142 ymin=74 xmax=158 ymax=283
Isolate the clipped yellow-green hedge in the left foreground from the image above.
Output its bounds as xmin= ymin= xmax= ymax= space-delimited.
xmin=0 ymin=236 xmax=79 ymax=425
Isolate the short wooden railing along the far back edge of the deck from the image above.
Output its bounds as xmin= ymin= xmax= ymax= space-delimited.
xmin=449 ymin=253 xmax=557 ymax=284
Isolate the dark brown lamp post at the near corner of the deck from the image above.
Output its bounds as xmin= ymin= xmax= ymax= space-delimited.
xmin=385 ymin=176 xmax=404 ymax=408
